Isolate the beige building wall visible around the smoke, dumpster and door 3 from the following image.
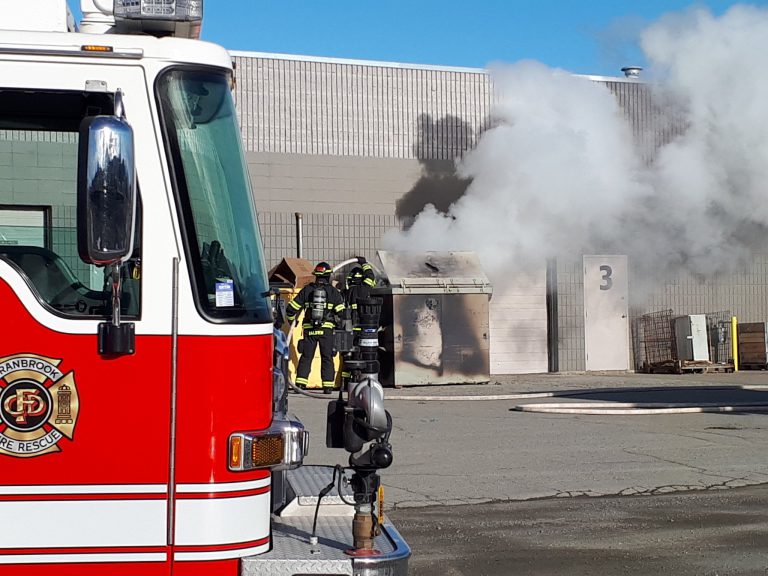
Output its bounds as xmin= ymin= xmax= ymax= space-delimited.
xmin=233 ymin=52 xmax=756 ymax=373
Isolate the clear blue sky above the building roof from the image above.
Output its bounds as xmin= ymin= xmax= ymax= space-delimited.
xmin=69 ymin=0 xmax=768 ymax=76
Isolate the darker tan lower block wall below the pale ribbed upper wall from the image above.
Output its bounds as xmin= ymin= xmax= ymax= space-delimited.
xmin=246 ymin=152 xmax=466 ymax=267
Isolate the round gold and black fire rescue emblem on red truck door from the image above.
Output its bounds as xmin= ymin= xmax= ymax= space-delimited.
xmin=0 ymin=354 xmax=80 ymax=458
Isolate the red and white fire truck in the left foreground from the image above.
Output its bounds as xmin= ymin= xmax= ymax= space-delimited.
xmin=0 ymin=0 xmax=410 ymax=576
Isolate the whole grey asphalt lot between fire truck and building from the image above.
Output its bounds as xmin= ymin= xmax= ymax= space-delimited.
xmin=289 ymin=372 xmax=768 ymax=576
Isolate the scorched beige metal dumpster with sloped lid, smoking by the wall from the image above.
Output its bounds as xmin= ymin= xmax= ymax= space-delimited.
xmin=373 ymin=251 xmax=492 ymax=387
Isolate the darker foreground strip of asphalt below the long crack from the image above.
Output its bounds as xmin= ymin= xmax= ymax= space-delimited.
xmin=390 ymin=486 xmax=768 ymax=576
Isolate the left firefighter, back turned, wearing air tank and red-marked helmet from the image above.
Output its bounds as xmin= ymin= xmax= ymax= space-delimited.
xmin=286 ymin=262 xmax=344 ymax=394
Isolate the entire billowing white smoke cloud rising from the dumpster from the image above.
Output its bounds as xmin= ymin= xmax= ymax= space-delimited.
xmin=384 ymin=6 xmax=768 ymax=288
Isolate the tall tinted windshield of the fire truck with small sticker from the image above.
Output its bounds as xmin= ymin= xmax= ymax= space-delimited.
xmin=157 ymin=68 xmax=272 ymax=322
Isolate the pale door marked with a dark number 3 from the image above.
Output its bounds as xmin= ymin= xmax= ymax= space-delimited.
xmin=584 ymin=256 xmax=629 ymax=371
